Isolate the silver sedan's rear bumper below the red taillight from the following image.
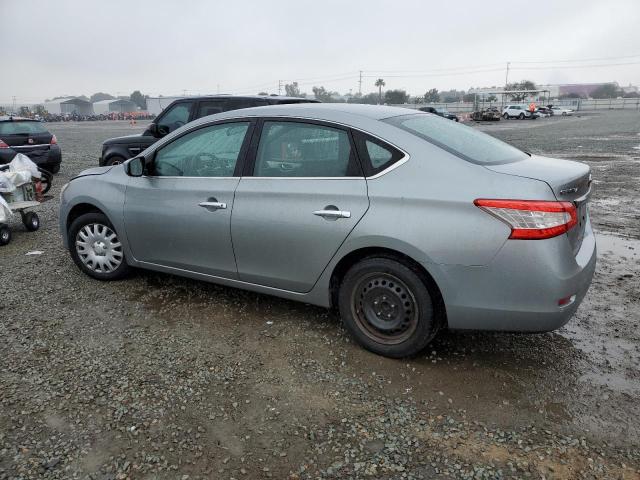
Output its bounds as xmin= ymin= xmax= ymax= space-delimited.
xmin=426 ymin=223 xmax=596 ymax=332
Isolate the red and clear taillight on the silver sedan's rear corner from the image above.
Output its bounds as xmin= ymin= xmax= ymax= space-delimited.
xmin=473 ymin=199 xmax=578 ymax=240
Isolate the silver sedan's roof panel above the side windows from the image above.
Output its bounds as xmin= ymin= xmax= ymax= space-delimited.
xmin=196 ymin=103 xmax=418 ymax=123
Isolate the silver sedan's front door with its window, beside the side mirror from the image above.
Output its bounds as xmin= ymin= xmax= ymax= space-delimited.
xmin=124 ymin=120 xmax=252 ymax=278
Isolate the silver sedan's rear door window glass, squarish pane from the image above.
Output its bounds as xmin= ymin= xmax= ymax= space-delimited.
xmin=253 ymin=121 xmax=362 ymax=177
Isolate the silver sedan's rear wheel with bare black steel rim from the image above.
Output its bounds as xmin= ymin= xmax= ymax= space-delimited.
xmin=338 ymin=257 xmax=442 ymax=358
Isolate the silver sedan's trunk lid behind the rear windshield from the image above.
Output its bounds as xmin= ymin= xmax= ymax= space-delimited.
xmin=486 ymin=155 xmax=591 ymax=255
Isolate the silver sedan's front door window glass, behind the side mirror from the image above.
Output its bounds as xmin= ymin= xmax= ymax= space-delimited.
xmin=152 ymin=122 xmax=249 ymax=177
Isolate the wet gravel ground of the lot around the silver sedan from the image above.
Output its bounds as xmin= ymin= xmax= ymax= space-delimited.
xmin=0 ymin=112 xmax=640 ymax=479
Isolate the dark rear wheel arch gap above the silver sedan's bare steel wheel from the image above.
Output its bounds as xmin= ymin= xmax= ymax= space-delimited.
xmin=329 ymin=247 xmax=447 ymax=326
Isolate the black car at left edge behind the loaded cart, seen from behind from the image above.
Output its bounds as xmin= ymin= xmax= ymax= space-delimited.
xmin=0 ymin=116 xmax=62 ymax=173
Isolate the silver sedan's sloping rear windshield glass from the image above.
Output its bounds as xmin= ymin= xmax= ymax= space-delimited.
xmin=383 ymin=113 xmax=528 ymax=165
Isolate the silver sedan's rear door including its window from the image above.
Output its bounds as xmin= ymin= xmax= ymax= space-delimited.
xmin=231 ymin=119 xmax=369 ymax=292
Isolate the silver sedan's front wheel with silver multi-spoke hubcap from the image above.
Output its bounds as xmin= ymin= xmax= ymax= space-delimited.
xmin=67 ymin=212 xmax=131 ymax=280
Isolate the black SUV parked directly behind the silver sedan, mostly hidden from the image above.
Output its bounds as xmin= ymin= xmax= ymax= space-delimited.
xmin=99 ymin=95 xmax=318 ymax=167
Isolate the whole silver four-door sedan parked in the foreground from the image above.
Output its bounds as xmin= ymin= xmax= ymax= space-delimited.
xmin=60 ymin=104 xmax=596 ymax=357
